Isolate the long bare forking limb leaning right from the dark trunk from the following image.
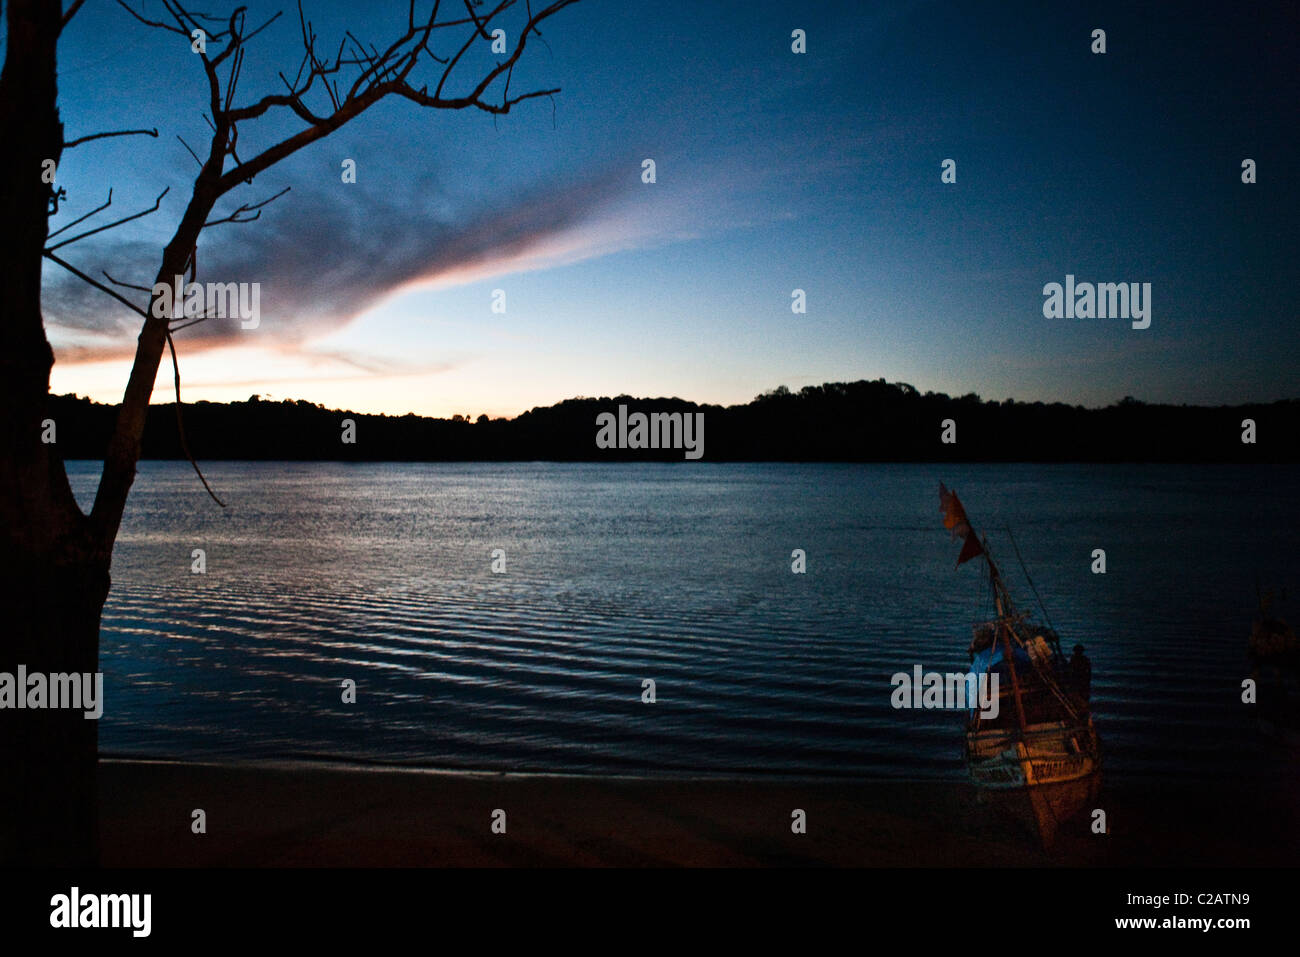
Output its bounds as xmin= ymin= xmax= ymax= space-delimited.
xmin=90 ymin=0 xmax=577 ymax=544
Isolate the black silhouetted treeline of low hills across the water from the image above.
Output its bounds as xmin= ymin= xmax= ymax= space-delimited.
xmin=51 ymin=380 xmax=1300 ymax=463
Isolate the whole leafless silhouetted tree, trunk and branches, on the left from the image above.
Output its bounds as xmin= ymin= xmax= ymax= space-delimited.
xmin=0 ymin=0 xmax=577 ymax=863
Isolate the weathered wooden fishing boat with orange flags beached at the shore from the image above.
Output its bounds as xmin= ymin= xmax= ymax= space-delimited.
xmin=939 ymin=482 xmax=1101 ymax=844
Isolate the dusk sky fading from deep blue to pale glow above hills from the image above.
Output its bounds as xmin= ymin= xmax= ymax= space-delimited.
xmin=30 ymin=0 xmax=1300 ymax=416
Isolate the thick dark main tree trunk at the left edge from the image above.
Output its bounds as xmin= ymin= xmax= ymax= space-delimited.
xmin=0 ymin=0 xmax=112 ymax=865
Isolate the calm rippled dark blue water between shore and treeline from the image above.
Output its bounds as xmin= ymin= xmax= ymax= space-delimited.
xmin=69 ymin=462 xmax=1300 ymax=779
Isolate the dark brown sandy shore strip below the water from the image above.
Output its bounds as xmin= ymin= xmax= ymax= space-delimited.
xmin=99 ymin=759 xmax=1297 ymax=867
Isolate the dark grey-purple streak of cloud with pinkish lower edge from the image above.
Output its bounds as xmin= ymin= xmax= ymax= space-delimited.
xmin=44 ymin=164 xmax=628 ymax=360
